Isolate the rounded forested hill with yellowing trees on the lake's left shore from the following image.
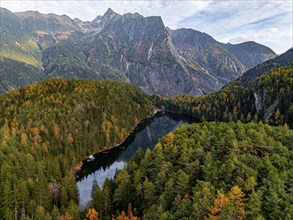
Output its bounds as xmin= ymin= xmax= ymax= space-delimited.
xmin=0 ymin=79 xmax=153 ymax=220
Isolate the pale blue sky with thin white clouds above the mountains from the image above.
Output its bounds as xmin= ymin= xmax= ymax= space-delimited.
xmin=0 ymin=0 xmax=293 ymax=54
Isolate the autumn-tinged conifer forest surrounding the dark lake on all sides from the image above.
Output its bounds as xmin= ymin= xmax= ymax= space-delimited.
xmin=0 ymin=62 xmax=293 ymax=220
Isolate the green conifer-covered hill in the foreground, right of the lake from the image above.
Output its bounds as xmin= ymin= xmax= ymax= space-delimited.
xmin=91 ymin=122 xmax=293 ymax=220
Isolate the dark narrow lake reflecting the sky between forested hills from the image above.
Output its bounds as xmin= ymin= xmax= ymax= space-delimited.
xmin=77 ymin=113 xmax=196 ymax=209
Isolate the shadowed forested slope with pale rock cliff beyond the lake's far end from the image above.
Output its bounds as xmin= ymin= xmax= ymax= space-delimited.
xmin=155 ymin=66 xmax=293 ymax=128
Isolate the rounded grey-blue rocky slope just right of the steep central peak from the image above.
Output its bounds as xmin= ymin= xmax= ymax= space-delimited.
xmin=169 ymin=29 xmax=246 ymax=85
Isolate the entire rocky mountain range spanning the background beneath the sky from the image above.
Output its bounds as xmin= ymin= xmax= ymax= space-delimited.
xmin=0 ymin=9 xmax=276 ymax=96
